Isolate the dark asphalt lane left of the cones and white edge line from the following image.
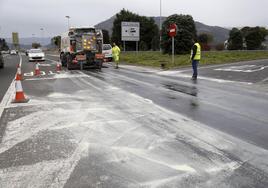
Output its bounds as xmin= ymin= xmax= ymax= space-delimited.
xmin=0 ymin=55 xmax=19 ymax=101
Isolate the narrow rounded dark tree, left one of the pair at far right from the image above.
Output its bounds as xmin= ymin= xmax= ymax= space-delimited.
xmin=228 ymin=28 xmax=243 ymax=50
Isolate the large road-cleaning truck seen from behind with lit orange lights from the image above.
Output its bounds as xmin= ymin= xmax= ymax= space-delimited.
xmin=60 ymin=27 xmax=104 ymax=69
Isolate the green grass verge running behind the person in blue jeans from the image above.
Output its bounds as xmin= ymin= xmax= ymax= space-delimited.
xmin=120 ymin=51 xmax=268 ymax=69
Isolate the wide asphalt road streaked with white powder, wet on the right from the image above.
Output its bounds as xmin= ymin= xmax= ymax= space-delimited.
xmin=0 ymin=53 xmax=268 ymax=188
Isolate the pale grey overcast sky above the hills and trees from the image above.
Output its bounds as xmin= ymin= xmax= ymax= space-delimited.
xmin=0 ymin=0 xmax=268 ymax=37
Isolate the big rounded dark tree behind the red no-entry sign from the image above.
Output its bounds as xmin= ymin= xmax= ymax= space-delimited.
xmin=161 ymin=14 xmax=197 ymax=54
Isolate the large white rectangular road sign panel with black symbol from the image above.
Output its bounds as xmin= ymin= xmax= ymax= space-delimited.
xmin=121 ymin=22 xmax=140 ymax=41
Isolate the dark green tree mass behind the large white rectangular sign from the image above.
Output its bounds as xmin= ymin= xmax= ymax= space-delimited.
xmin=112 ymin=9 xmax=159 ymax=50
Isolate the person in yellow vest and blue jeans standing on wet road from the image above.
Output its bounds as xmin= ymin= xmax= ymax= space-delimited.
xmin=190 ymin=40 xmax=201 ymax=80
